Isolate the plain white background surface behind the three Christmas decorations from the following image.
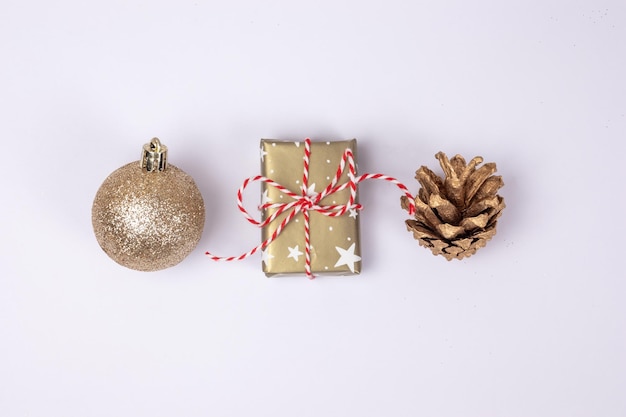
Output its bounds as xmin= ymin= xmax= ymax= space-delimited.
xmin=0 ymin=0 xmax=626 ymax=417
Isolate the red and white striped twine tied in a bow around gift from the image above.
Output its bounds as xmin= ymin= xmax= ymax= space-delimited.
xmin=206 ymin=138 xmax=415 ymax=279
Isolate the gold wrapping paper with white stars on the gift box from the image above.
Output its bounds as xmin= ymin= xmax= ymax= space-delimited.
xmin=261 ymin=139 xmax=361 ymax=277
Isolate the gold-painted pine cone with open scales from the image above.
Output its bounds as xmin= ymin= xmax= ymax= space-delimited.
xmin=402 ymin=152 xmax=505 ymax=261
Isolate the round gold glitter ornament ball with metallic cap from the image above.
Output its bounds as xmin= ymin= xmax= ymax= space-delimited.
xmin=91 ymin=138 xmax=205 ymax=271
